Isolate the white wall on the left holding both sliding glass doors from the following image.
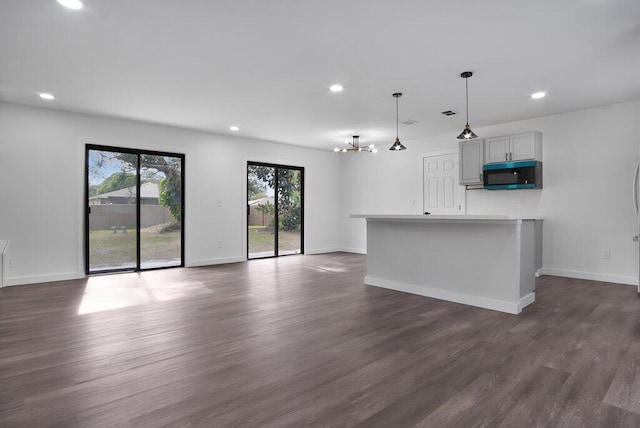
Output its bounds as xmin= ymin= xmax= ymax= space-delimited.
xmin=0 ymin=103 xmax=341 ymax=285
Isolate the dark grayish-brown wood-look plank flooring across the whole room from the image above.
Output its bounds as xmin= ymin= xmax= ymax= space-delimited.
xmin=0 ymin=253 xmax=640 ymax=427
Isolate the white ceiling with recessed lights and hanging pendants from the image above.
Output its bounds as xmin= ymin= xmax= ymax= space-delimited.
xmin=0 ymin=0 xmax=640 ymax=150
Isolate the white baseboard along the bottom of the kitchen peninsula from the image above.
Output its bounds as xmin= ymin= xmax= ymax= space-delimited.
xmin=364 ymin=276 xmax=535 ymax=314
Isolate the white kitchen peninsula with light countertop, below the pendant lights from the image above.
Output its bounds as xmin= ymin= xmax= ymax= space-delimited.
xmin=351 ymin=214 xmax=542 ymax=314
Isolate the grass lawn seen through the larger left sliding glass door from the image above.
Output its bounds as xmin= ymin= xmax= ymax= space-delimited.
xmin=89 ymin=228 xmax=181 ymax=270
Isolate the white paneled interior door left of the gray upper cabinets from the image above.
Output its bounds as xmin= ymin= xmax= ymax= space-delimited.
xmin=422 ymin=153 xmax=465 ymax=215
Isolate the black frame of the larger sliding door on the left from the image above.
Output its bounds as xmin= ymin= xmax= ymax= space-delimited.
xmin=84 ymin=144 xmax=185 ymax=275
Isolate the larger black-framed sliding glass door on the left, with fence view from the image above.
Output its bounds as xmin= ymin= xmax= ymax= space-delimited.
xmin=85 ymin=145 xmax=184 ymax=274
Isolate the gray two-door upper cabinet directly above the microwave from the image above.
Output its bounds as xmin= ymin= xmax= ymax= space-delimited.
xmin=485 ymin=131 xmax=542 ymax=163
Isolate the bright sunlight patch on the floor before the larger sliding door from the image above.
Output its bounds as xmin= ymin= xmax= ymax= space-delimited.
xmin=78 ymin=269 xmax=212 ymax=315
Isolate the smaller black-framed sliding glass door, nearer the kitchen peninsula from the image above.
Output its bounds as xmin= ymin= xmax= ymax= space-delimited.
xmin=247 ymin=162 xmax=304 ymax=259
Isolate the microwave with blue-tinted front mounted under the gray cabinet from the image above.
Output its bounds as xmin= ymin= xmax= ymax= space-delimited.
xmin=483 ymin=161 xmax=542 ymax=190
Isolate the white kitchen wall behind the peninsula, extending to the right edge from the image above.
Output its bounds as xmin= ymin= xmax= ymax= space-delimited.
xmin=342 ymin=101 xmax=640 ymax=284
